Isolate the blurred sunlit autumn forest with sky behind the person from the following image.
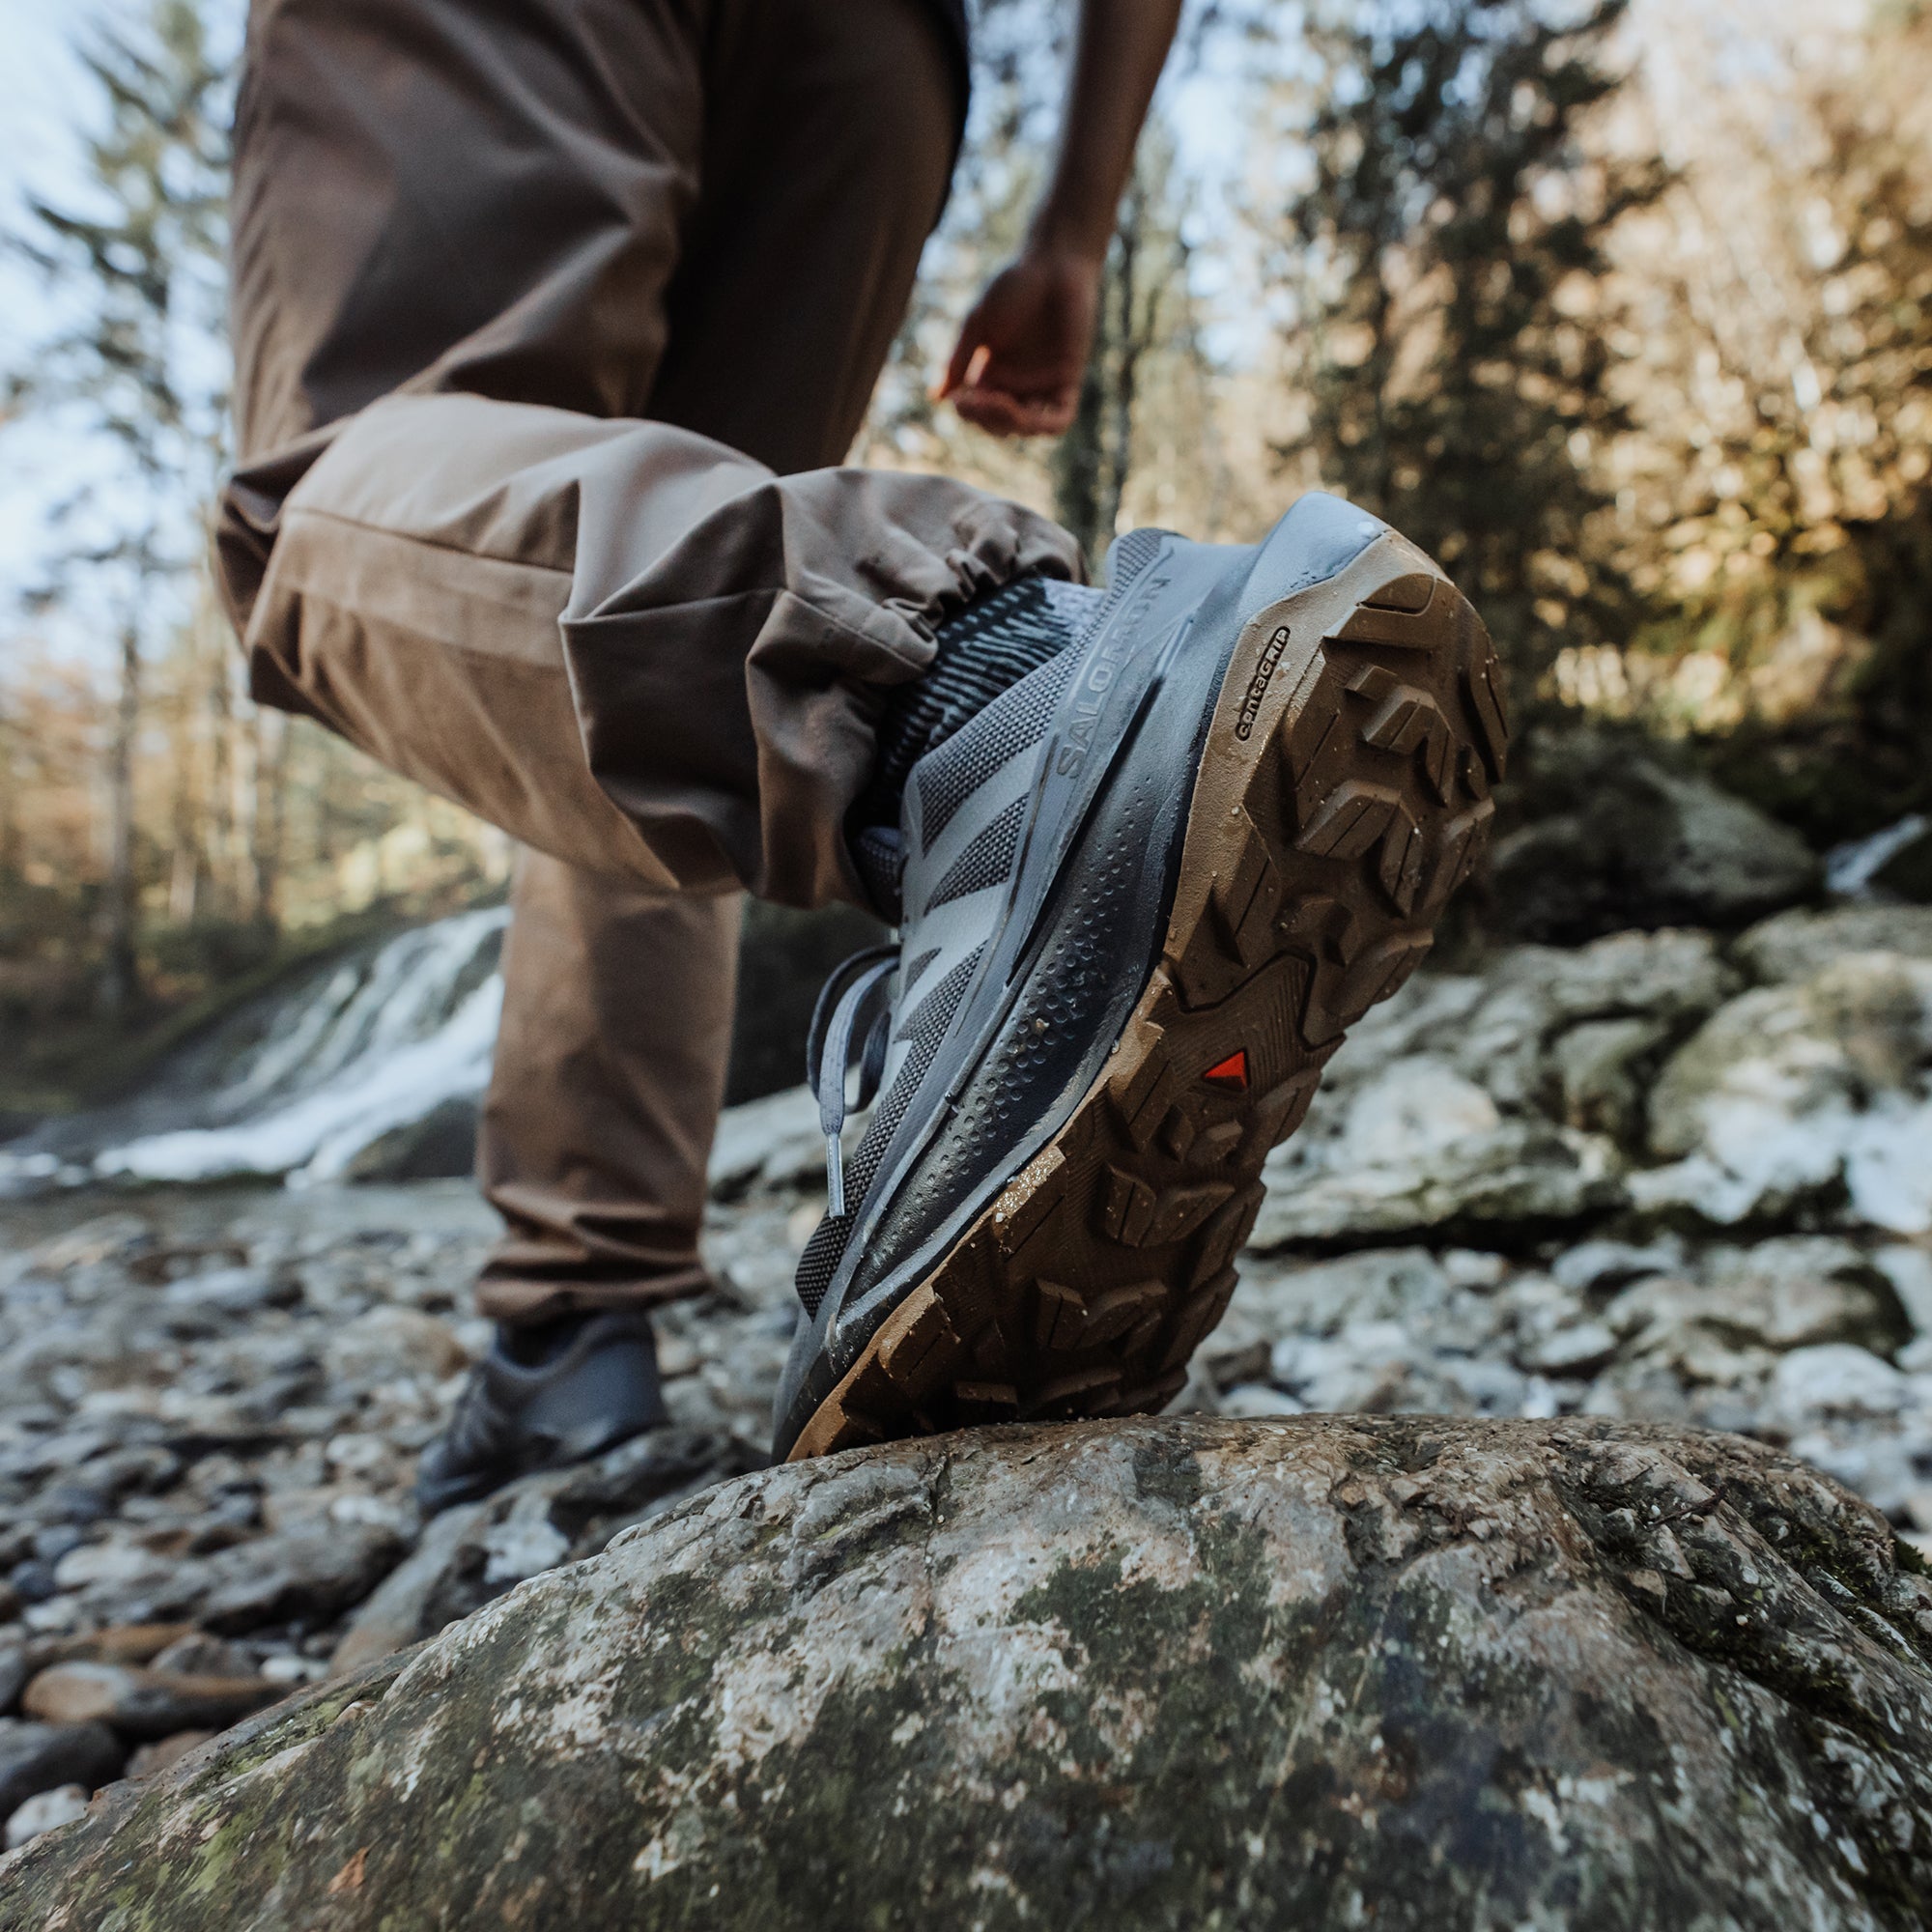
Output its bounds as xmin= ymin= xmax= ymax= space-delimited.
xmin=0 ymin=0 xmax=1932 ymax=1121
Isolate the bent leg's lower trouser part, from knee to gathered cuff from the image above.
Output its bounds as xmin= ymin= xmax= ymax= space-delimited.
xmin=224 ymin=394 xmax=1078 ymax=906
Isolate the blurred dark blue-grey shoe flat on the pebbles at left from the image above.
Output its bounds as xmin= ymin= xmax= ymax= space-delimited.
xmin=415 ymin=1312 xmax=665 ymax=1515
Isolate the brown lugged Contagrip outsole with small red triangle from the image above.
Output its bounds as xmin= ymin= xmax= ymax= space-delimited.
xmin=790 ymin=533 xmax=1509 ymax=1461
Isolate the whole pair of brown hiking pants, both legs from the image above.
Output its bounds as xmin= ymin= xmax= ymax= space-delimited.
xmin=218 ymin=0 xmax=1078 ymax=1320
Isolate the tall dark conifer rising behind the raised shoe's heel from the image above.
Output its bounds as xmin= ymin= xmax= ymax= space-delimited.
xmin=1279 ymin=0 xmax=1667 ymax=697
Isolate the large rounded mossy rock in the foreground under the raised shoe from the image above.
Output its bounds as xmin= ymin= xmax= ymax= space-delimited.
xmin=0 ymin=1418 xmax=1932 ymax=1932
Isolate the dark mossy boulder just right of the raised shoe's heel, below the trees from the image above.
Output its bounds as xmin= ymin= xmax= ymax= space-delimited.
xmin=1492 ymin=734 xmax=1822 ymax=945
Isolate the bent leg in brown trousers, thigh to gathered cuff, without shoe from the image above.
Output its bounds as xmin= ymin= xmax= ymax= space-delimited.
xmin=220 ymin=0 xmax=1076 ymax=904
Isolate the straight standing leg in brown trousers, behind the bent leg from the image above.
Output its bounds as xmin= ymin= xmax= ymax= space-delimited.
xmin=477 ymin=0 xmax=958 ymax=1321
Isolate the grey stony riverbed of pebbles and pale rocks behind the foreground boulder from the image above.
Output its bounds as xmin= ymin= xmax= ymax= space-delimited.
xmin=0 ymin=906 xmax=1932 ymax=1843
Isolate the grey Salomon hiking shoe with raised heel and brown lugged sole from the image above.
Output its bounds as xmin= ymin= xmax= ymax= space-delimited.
xmin=775 ymin=495 xmax=1507 ymax=1457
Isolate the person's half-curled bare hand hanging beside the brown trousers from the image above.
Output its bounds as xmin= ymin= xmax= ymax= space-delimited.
xmin=933 ymin=245 xmax=1101 ymax=437
